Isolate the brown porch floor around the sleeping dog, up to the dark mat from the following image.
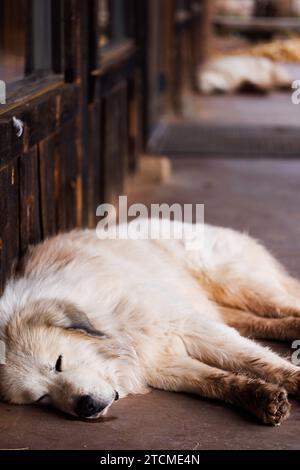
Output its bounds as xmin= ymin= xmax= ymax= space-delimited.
xmin=0 ymin=158 xmax=300 ymax=450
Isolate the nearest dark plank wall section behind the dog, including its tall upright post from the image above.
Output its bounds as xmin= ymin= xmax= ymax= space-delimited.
xmin=0 ymin=0 xmax=141 ymax=294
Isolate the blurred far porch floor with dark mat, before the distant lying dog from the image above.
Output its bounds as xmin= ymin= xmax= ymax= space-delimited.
xmin=149 ymin=89 xmax=300 ymax=159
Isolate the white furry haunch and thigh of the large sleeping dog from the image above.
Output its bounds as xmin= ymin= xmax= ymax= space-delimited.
xmin=186 ymin=227 xmax=300 ymax=318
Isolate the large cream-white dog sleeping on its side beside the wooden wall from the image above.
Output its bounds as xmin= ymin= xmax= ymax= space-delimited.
xmin=0 ymin=222 xmax=300 ymax=425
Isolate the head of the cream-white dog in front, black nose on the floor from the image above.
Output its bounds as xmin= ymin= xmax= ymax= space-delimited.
xmin=0 ymin=300 xmax=119 ymax=418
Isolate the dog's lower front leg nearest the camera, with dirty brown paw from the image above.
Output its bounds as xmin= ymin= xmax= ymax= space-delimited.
xmin=147 ymin=356 xmax=290 ymax=426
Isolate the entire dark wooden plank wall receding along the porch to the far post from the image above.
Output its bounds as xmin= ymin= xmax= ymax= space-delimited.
xmin=0 ymin=0 xmax=201 ymax=294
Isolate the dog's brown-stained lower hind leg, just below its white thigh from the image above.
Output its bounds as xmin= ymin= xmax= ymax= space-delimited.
xmin=218 ymin=307 xmax=300 ymax=341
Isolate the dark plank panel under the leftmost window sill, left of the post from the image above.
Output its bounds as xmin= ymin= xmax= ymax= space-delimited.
xmin=0 ymin=81 xmax=78 ymax=292
